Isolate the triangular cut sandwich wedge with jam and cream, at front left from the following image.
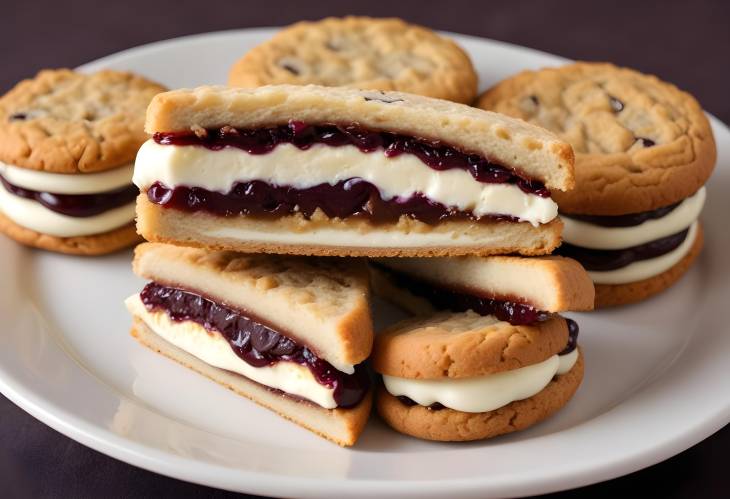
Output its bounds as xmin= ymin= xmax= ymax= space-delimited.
xmin=126 ymin=243 xmax=373 ymax=445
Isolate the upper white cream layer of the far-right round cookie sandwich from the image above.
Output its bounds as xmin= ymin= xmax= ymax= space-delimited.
xmin=560 ymin=187 xmax=706 ymax=250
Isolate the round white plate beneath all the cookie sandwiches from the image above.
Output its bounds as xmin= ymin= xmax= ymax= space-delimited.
xmin=0 ymin=29 xmax=730 ymax=498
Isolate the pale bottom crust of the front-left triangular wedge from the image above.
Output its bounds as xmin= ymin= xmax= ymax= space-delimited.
xmin=131 ymin=317 xmax=372 ymax=446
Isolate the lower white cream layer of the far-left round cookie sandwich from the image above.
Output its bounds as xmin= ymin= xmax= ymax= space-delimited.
xmin=0 ymin=186 xmax=135 ymax=237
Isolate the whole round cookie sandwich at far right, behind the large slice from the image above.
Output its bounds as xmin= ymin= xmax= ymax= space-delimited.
xmin=478 ymin=63 xmax=717 ymax=307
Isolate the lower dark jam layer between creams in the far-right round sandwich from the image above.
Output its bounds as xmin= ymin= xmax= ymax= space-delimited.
xmin=555 ymin=229 xmax=689 ymax=271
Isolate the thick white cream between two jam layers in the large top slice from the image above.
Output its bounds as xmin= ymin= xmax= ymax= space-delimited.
xmin=134 ymin=140 xmax=558 ymax=226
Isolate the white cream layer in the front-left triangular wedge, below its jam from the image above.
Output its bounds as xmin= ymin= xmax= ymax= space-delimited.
xmin=125 ymin=295 xmax=337 ymax=409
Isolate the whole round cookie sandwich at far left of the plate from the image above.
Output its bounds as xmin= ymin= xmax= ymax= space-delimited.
xmin=0 ymin=69 xmax=165 ymax=255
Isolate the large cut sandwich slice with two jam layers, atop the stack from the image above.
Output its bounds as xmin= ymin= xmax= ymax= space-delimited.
xmin=134 ymin=85 xmax=573 ymax=256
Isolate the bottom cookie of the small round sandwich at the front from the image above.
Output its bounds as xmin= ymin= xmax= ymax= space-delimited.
xmin=376 ymin=352 xmax=584 ymax=442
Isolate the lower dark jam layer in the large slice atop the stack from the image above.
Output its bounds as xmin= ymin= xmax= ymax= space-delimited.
xmin=147 ymin=178 xmax=519 ymax=225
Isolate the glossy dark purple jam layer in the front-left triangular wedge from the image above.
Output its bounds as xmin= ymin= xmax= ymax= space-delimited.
xmin=140 ymin=282 xmax=370 ymax=407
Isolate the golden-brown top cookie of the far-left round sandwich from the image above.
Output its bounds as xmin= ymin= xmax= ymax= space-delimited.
xmin=0 ymin=69 xmax=166 ymax=173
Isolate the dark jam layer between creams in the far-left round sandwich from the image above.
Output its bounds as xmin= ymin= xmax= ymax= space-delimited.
xmin=0 ymin=175 xmax=139 ymax=218
